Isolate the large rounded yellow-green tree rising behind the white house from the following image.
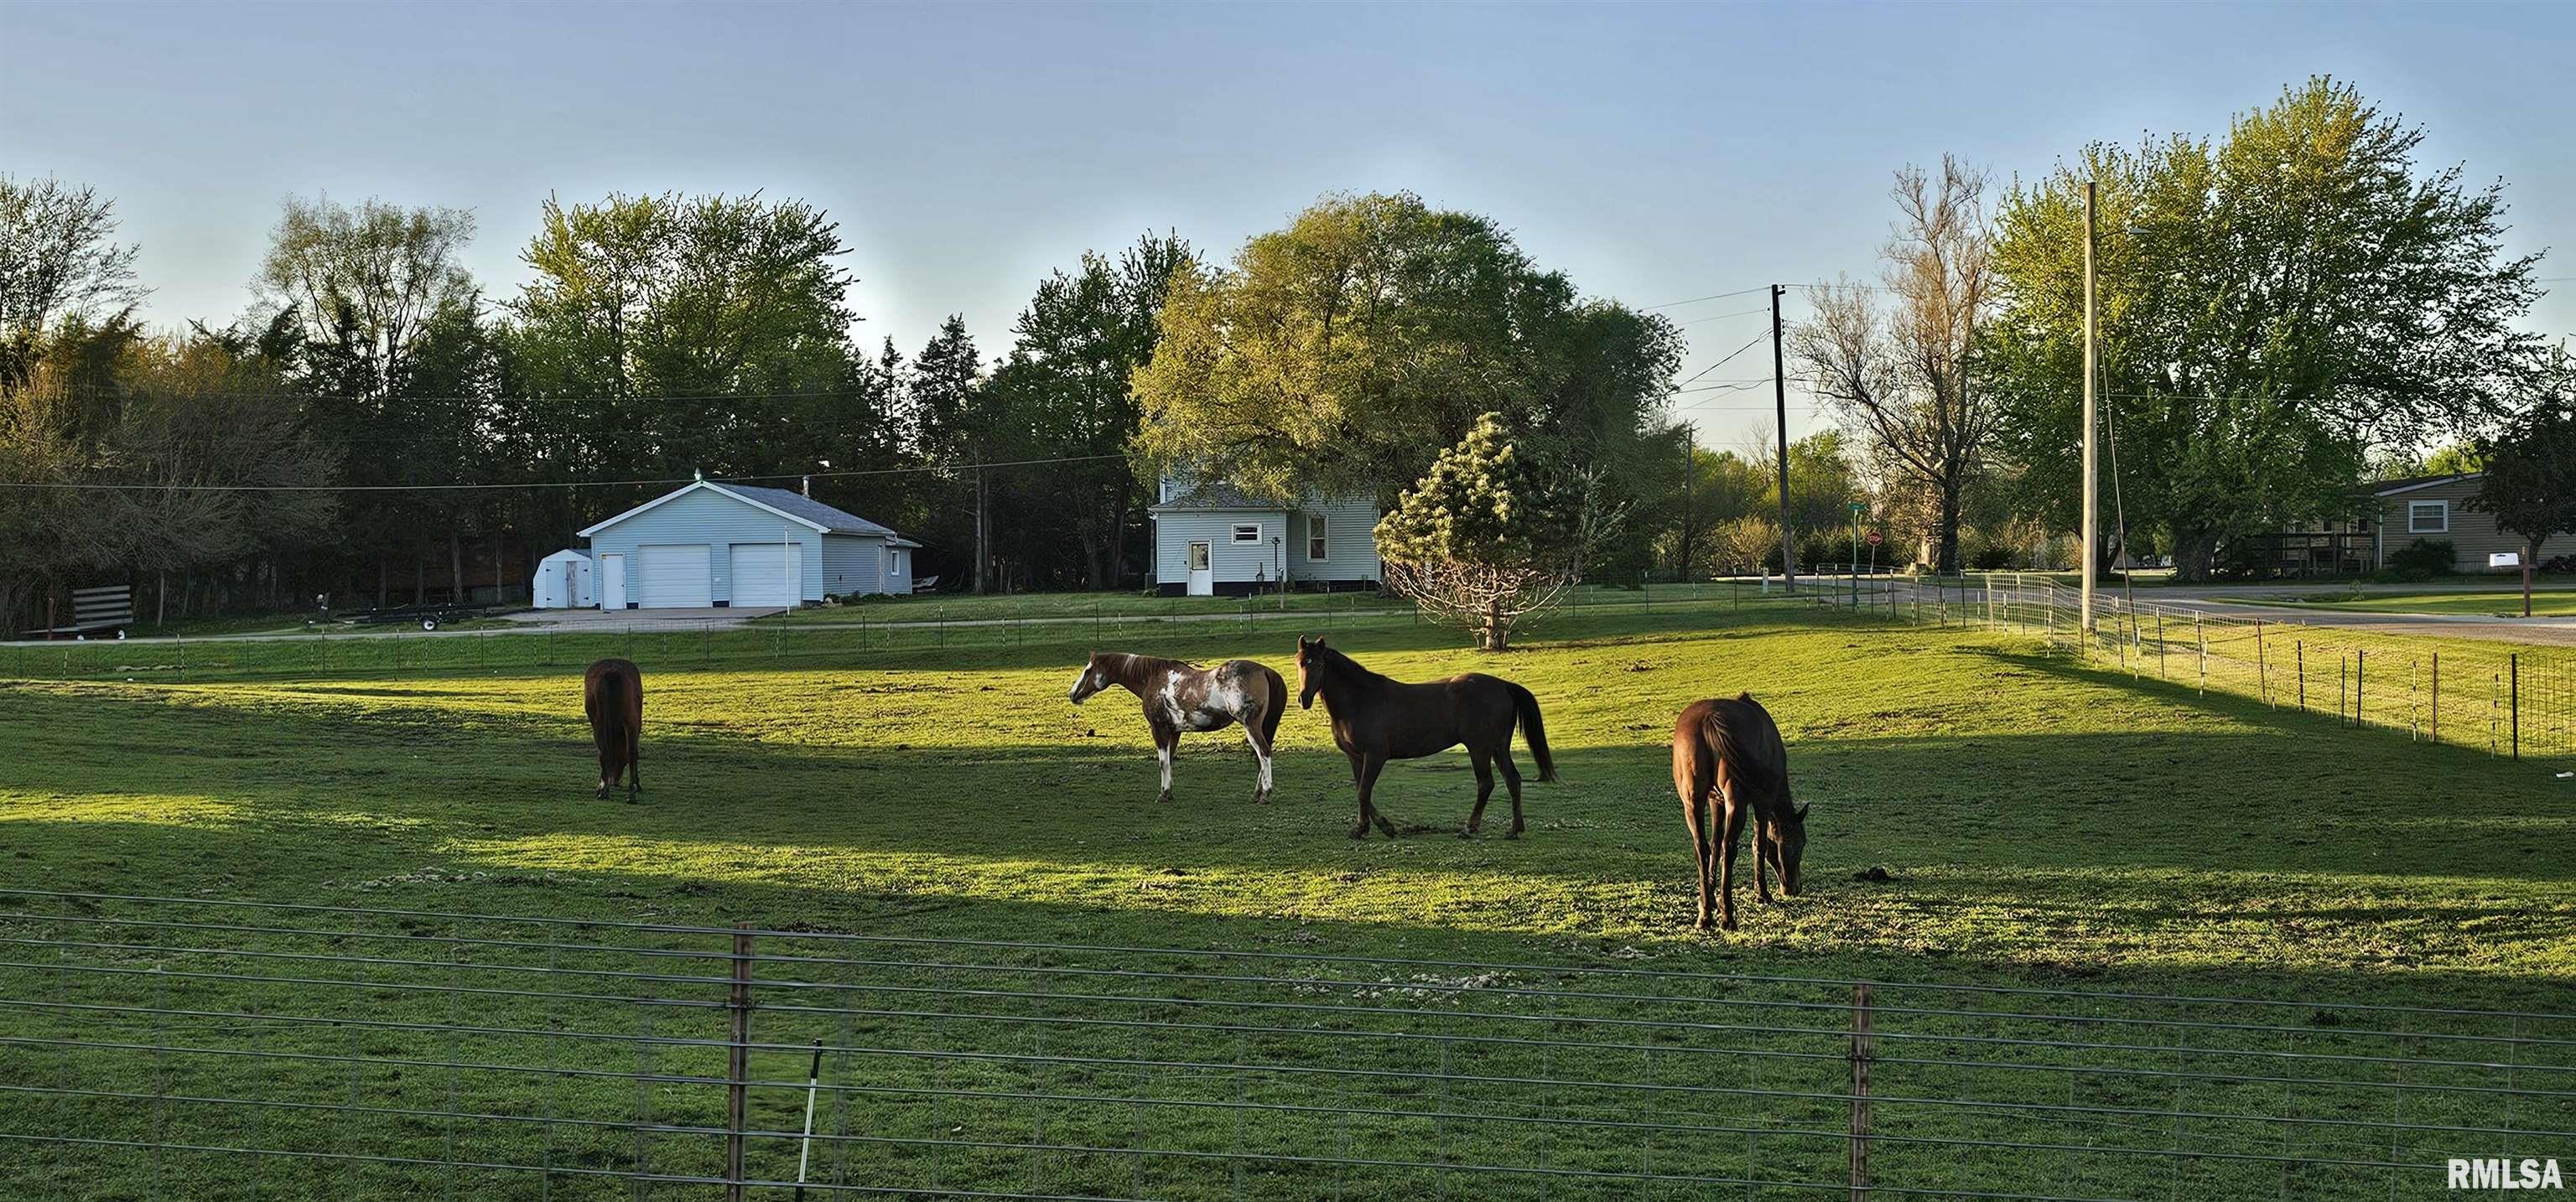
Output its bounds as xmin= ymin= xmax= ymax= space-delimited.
xmin=1136 ymin=193 xmax=1677 ymax=502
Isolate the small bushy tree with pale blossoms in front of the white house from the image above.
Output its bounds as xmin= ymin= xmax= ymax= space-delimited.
xmin=1379 ymin=414 xmax=1620 ymax=651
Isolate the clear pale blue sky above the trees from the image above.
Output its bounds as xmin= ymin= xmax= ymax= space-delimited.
xmin=0 ymin=0 xmax=2576 ymax=448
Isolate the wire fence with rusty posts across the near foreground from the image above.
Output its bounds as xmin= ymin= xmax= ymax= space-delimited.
xmin=0 ymin=890 xmax=2576 ymax=1199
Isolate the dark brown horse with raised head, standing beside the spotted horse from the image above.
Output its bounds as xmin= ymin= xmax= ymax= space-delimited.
xmin=1296 ymin=635 xmax=1555 ymax=839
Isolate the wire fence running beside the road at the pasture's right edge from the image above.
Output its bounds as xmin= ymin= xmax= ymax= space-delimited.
xmin=1803 ymin=572 xmax=2576 ymax=759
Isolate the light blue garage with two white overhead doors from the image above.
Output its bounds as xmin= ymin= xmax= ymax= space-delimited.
xmin=579 ymin=481 xmax=920 ymax=610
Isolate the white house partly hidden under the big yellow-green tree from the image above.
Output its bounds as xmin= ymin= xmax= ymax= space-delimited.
xmin=1146 ymin=476 xmax=1379 ymax=597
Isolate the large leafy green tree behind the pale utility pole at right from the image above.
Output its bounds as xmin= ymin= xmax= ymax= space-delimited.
xmin=1978 ymin=77 xmax=2540 ymax=579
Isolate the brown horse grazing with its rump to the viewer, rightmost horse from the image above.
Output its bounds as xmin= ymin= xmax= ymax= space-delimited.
xmin=1672 ymin=692 xmax=1805 ymax=932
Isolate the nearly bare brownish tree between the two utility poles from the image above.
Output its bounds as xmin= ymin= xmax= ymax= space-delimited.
xmin=1793 ymin=154 xmax=1994 ymax=572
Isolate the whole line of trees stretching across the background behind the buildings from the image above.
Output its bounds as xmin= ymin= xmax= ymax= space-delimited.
xmin=0 ymin=77 xmax=2571 ymax=635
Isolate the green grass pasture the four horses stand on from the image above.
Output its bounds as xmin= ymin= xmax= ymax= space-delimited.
xmin=0 ymin=597 xmax=2576 ymax=1199
